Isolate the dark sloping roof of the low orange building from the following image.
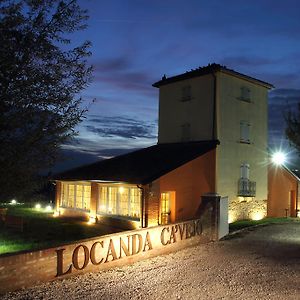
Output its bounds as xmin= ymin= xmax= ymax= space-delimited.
xmin=54 ymin=141 xmax=219 ymax=184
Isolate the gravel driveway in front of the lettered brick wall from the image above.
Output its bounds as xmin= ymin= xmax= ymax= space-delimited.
xmin=1 ymin=223 xmax=300 ymax=300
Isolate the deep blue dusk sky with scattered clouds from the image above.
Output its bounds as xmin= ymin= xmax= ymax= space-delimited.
xmin=56 ymin=0 xmax=300 ymax=171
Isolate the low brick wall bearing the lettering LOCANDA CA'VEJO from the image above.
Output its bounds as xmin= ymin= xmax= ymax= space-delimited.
xmin=0 ymin=198 xmax=218 ymax=294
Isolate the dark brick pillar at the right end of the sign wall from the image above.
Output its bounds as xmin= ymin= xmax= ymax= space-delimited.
xmin=199 ymin=193 xmax=221 ymax=241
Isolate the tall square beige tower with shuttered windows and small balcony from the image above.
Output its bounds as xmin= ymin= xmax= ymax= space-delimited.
xmin=154 ymin=67 xmax=271 ymax=222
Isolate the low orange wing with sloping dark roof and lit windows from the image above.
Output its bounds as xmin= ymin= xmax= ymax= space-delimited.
xmin=56 ymin=141 xmax=218 ymax=229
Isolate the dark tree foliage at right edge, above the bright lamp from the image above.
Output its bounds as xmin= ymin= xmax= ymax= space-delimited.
xmin=285 ymin=103 xmax=300 ymax=151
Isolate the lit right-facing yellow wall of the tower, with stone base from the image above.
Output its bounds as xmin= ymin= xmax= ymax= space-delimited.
xmin=217 ymin=72 xmax=268 ymax=221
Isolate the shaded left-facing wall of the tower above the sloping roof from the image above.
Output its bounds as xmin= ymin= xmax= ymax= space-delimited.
xmin=158 ymin=75 xmax=214 ymax=143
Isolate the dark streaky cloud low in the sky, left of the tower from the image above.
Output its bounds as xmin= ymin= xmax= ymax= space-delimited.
xmin=86 ymin=116 xmax=156 ymax=139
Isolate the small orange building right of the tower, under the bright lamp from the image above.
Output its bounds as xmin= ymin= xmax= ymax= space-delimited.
xmin=268 ymin=164 xmax=300 ymax=217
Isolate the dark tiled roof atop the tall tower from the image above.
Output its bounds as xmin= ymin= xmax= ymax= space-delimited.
xmin=152 ymin=63 xmax=274 ymax=89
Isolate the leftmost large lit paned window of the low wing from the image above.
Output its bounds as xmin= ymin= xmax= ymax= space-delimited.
xmin=61 ymin=183 xmax=91 ymax=210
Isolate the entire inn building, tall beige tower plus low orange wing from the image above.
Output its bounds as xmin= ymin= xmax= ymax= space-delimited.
xmin=56 ymin=64 xmax=272 ymax=228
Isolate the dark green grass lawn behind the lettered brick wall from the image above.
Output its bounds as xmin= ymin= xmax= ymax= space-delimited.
xmin=0 ymin=205 xmax=121 ymax=255
